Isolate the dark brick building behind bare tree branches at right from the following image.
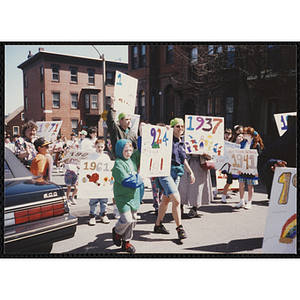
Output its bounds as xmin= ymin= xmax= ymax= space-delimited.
xmin=128 ymin=44 xmax=297 ymax=146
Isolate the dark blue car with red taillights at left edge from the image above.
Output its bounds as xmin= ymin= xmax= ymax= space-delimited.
xmin=4 ymin=148 xmax=77 ymax=254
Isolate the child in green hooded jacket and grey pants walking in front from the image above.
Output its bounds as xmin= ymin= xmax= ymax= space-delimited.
xmin=112 ymin=139 xmax=143 ymax=253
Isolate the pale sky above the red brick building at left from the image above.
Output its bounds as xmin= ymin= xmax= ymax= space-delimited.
xmin=4 ymin=44 xmax=128 ymax=115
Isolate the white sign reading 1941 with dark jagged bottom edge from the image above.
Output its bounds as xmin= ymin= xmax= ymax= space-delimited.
xmin=226 ymin=148 xmax=258 ymax=179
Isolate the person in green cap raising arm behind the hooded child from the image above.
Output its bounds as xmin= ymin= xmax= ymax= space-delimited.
xmin=107 ymin=100 xmax=137 ymax=158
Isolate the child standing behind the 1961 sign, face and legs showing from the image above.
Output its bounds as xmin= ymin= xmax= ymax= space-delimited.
xmin=87 ymin=139 xmax=110 ymax=226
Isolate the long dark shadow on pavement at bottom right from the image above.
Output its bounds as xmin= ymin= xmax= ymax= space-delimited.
xmin=185 ymin=238 xmax=263 ymax=253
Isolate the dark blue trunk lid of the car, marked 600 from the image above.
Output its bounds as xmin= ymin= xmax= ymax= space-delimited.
xmin=4 ymin=178 xmax=64 ymax=209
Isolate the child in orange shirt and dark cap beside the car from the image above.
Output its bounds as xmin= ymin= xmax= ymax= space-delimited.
xmin=30 ymin=138 xmax=52 ymax=180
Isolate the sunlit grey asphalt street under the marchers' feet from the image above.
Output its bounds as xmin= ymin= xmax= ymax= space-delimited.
xmin=51 ymin=169 xmax=269 ymax=257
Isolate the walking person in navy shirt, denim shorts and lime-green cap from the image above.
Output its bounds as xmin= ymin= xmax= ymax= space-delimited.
xmin=154 ymin=118 xmax=195 ymax=239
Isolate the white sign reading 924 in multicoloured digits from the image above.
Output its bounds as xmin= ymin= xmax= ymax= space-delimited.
xmin=140 ymin=124 xmax=173 ymax=177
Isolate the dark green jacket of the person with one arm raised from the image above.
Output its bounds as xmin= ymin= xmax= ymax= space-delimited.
xmin=106 ymin=108 xmax=137 ymax=158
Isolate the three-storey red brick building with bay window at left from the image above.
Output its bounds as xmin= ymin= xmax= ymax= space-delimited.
xmin=18 ymin=48 xmax=128 ymax=137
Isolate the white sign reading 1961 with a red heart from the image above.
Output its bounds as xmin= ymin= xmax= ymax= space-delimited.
xmin=77 ymin=158 xmax=114 ymax=198
